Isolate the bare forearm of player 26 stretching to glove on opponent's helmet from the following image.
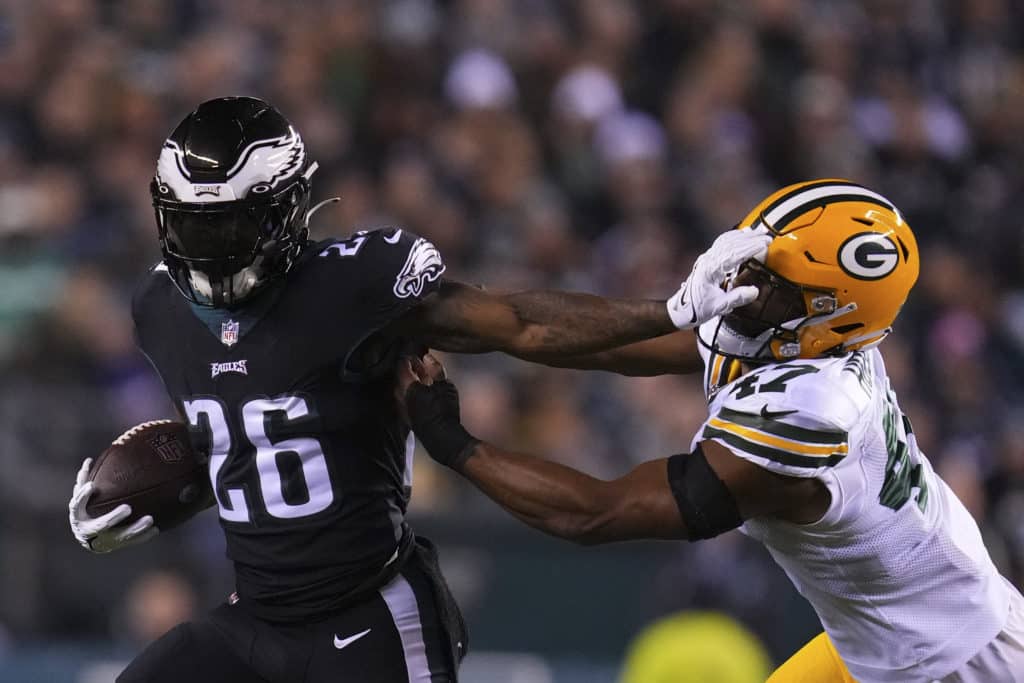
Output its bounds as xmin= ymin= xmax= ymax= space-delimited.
xmin=498 ymin=292 xmax=676 ymax=362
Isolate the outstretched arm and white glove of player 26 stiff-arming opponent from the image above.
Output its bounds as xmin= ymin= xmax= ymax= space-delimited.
xmin=397 ymin=230 xmax=770 ymax=374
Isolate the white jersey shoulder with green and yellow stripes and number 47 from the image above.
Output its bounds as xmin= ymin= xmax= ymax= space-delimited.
xmin=700 ymin=354 xmax=871 ymax=477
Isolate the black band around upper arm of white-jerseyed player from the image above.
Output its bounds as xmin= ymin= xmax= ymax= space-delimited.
xmin=669 ymin=445 xmax=743 ymax=541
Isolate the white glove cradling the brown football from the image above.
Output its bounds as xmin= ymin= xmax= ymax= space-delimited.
xmin=68 ymin=458 xmax=159 ymax=553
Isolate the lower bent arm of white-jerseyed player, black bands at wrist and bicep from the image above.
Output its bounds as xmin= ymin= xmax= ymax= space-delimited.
xmin=399 ymin=355 xmax=828 ymax=545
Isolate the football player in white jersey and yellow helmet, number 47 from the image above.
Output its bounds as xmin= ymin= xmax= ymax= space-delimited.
xmin=402 ymin=180 xmax=1024 ymax=683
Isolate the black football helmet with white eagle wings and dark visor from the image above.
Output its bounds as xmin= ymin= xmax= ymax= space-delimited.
xmin=150 ymin=97 xmax=316 ymax=308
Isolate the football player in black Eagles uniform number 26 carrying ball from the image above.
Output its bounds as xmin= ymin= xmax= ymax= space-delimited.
xmin=64 ymin=97 xmax=756 ymax=683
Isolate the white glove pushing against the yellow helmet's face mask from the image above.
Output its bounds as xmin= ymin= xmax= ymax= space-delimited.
xmin=668 ymin=227 xmax=772 ymax=330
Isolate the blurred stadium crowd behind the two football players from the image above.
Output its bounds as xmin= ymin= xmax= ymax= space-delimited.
xmin=0 ymin=0 xmax=1024 ymax=683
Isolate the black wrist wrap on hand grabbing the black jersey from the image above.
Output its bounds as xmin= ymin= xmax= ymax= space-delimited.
xmin=406 ymin=380 xmax=480 ymax=470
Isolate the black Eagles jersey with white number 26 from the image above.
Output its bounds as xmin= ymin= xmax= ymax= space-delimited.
xmin=133 ymin=229 xmax=444 ymax=620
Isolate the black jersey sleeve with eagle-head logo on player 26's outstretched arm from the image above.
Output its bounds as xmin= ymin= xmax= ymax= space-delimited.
xmin=317 ymin=228 xmax=444 ymax=375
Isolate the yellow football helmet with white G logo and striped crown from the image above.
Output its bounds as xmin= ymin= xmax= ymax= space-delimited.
xmin=700 ymin=179 xmax=921 ymax=360
